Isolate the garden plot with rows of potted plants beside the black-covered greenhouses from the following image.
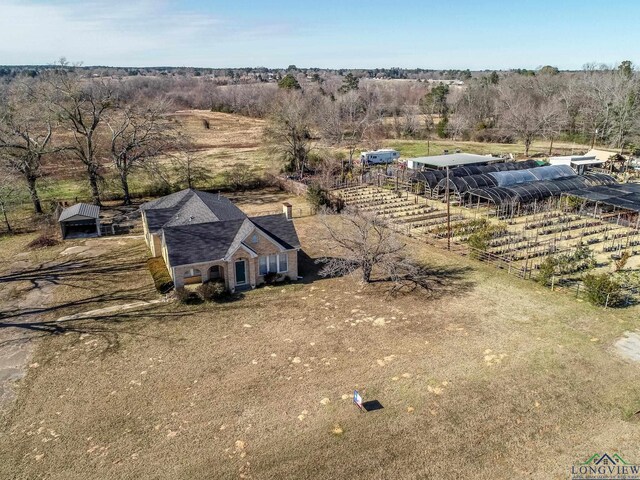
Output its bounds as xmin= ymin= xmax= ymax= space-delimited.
xmin=336 ymin=186 xmax=640 ymax=286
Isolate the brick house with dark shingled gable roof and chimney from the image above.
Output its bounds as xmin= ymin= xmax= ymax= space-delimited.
xmin=140 ymin=189 xmax=300 ymax=291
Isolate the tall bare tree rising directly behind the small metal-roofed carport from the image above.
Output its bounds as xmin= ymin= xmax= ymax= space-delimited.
xmin=48 ymin=68 xmax=116 ymax=205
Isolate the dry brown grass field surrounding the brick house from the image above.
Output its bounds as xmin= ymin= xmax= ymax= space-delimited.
xmin=0 ymin=192 xmax=640 ymax=479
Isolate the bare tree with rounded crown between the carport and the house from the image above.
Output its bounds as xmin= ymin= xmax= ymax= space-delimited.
xmin=107 ymin=101 xmax=174 ymax=205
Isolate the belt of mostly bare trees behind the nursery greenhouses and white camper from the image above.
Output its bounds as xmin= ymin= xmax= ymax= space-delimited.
xmin=267 ymin=61 xmax=640 ymax=179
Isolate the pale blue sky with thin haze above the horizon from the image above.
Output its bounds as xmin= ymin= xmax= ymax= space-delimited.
xmin=0 ymin=0 xmax=640 ymax=70
